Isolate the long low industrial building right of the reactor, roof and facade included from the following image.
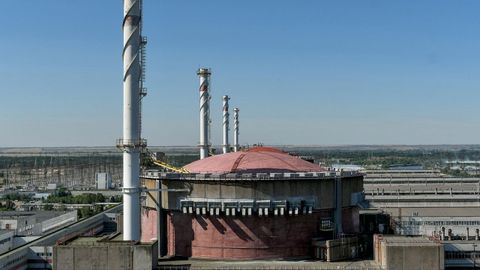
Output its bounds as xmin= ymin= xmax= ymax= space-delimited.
xmin=364 ymin=170 xmax=480 ymax=269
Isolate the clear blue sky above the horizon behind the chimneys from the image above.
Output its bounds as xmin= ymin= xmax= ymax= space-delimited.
xmin=0 ymin=0 xmax=480 ymax=147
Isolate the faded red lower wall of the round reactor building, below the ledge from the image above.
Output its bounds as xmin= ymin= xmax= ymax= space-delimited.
xmin=168 ymin=210 xmax=351 ymax=259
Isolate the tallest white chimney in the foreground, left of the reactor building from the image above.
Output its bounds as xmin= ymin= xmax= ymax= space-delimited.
xmin=117 ymin=0 xmax=142 ymax=241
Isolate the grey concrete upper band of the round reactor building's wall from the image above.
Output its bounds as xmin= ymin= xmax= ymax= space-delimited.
xmin=144 ymin=177 xmax=363 ymax=209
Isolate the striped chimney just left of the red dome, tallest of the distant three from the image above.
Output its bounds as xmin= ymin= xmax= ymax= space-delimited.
xmin=197 ymin=68 xmax=212 ymax=159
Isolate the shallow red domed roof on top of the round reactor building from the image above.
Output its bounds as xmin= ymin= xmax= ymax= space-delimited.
xmin=184 ymin=147 xmax=325 ymax=173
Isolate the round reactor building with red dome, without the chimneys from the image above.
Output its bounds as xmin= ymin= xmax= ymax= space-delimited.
xmin=142 ymin=147 xmax=363 ymax=259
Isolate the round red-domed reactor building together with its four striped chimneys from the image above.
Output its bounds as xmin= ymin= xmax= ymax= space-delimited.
xmin=124 ymin=0 xmax=363 ymax=260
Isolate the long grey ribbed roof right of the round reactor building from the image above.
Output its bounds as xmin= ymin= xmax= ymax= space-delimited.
xmin=364 ymin=170 xmax=480 ymax=208
